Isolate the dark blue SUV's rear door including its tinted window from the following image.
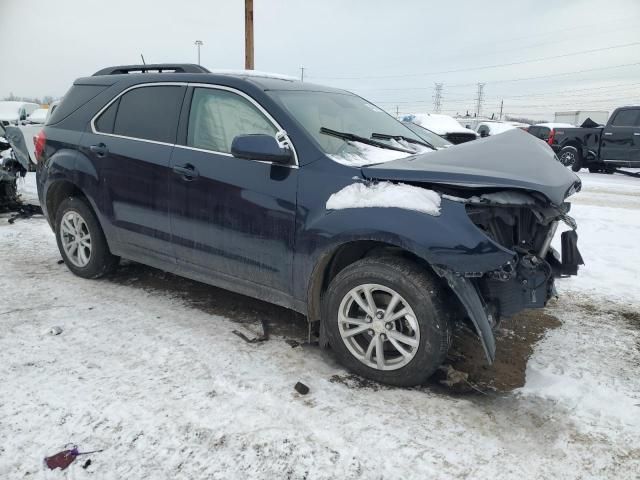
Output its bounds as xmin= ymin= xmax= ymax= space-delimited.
xmin=82 ymin=84 xmax=186 ymax=263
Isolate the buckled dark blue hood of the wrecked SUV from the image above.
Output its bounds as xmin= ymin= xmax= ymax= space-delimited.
xmin=362 ymin=129 xmax=581 ymax=205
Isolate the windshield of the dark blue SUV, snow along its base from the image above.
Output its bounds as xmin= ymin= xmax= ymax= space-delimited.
xmin=269 ymin=90 xmax=431 ymax=166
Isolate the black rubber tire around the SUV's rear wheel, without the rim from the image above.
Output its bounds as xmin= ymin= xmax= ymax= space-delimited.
xmin=55 ymin=197 xmax=120 ymax=278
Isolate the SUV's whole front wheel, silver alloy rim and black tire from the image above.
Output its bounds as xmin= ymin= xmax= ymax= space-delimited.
xmin=323 ymin=257 xmax=451 ymax=386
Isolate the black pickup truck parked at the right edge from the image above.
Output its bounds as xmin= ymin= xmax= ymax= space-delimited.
xmin=548 ymin=106 xmax=640 ymax=173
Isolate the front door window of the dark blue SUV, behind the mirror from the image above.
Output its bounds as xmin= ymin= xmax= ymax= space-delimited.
xmin=187 ymin=88 xmax=278 ymax=153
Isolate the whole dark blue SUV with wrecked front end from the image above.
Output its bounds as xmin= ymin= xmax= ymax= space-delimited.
xmin=36 ymin=65 xmax=581 ymax=385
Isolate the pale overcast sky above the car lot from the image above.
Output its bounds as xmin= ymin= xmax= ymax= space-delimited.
xmin=0 ymin=0 xmax=640 ymax=118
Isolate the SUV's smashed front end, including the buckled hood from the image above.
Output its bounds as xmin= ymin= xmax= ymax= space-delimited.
xmin=362 ymin=130 xmax=583 ymax=362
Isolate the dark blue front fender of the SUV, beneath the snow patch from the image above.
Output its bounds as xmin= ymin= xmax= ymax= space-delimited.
xmin=294 ymin=199 xmax=515 ymax=363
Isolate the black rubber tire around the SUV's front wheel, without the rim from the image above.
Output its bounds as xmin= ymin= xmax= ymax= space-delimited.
xmin=323 ymin=257 xmax=451 ymax=387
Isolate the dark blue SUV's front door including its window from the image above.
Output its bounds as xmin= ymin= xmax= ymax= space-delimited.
xmin=170 ymin=87 xmax=298 ymax=293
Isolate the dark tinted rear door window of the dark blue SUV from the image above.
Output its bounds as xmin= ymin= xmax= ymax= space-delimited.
xmin=95 ymin=85 xmax=186 ymax=143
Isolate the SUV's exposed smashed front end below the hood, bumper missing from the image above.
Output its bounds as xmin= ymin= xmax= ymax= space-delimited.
xmin=438 ymin=189 xmax=583 ymax=362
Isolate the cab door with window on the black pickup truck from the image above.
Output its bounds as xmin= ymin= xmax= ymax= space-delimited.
xmin=600 ymin=108 xmax=640 ymax=165
